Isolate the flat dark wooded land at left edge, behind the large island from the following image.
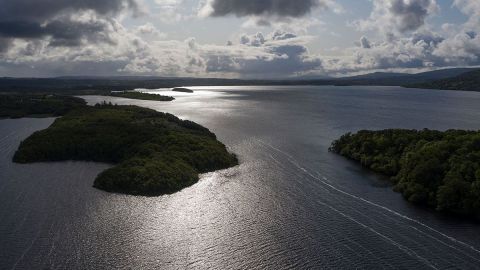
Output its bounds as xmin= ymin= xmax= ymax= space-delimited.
xmin=0 ymin=95 xmax=86 ymax=118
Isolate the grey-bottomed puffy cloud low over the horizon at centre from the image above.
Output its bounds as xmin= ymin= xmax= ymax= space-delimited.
xmin=202 ymin=31 xmax=323 ymax=78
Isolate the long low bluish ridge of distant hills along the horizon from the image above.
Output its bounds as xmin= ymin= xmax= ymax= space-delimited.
xmin=0 ymin=68 xmax=474 ymax=95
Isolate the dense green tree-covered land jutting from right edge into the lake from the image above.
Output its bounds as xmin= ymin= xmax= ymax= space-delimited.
xmin=330 ymin=129 xmax=480 ymax=219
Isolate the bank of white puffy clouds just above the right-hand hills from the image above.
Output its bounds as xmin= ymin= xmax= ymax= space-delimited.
xmin=323 ymin=27 xmax=480 ymax=75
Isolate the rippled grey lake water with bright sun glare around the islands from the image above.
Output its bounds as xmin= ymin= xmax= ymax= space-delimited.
xmin=0 ymin=86 xmax=480 ymax=269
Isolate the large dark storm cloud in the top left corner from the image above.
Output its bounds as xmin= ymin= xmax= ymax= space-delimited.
xmin=0 ymin=0 xmax=138 ymax=47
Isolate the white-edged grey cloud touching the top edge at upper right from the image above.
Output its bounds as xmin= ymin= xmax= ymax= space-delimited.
xmin=355 ymin=0 xmax=439 ymax=33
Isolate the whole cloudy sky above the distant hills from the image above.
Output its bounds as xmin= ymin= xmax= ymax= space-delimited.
xmin=0 ymin=0 xmax=480 ymax=79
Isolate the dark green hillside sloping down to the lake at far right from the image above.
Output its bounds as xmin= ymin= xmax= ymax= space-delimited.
xmin=407 ymin=69 xmax=480 ymax=91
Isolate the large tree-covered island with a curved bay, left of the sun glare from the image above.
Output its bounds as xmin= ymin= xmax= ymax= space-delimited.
xmin=13 ymin=104 xmax=238 ymax=196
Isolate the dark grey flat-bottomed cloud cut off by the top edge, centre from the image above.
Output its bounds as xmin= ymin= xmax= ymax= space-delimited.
xmin=202 ymin=0 xmax=325 ymax=17
